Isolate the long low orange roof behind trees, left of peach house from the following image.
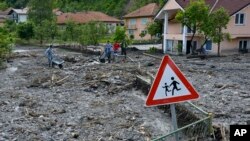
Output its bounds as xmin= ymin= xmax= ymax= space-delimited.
xmin=57 ymin=11 xmax=120 ymax=24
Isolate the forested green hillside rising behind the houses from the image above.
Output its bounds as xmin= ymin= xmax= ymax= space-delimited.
xmin=0 ymin=0 xmax=165 ymax=18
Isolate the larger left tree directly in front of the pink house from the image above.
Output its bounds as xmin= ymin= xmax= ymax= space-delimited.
xmin=175 ymin=0 xmax=209 ymax=53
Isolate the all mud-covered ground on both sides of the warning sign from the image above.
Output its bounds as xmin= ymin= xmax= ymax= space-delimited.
xmin=0 ymin=48 xmax=250 ymax=141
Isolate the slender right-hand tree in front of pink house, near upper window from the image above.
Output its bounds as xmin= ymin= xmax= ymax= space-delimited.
xmin=210 ymin=8 xmax=230 ymax=56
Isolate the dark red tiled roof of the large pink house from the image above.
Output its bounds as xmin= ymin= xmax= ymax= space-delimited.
xmin=176 ymin=0 xmax=250 ymax=15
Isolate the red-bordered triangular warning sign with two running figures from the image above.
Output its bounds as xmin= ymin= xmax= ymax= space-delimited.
xmin=146 ymin=56 xmax=199 ymax=106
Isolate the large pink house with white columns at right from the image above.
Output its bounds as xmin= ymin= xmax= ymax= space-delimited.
xmin=155 ymin=0 xmax=250 ymax=54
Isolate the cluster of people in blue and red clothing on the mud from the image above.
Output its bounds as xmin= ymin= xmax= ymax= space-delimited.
xmin=104 ymin=40 xmax=128 ymax=63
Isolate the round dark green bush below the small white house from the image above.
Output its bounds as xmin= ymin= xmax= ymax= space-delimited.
xmin=17 ymin=22 xmax=35 ymax=40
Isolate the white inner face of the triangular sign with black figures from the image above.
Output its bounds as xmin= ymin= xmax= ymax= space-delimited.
xmin=153 ymin=65 xmax=190 ymax=100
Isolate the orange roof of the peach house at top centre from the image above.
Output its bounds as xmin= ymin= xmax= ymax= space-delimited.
xmin=124 ymin=3 xmax=159 ymax=18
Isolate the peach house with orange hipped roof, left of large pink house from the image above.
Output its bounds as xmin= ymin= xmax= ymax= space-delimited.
xmin=123 ymin=3 xmax=159 ymax=40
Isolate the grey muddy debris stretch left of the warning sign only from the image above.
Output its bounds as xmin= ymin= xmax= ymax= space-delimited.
xmin=0 ymin=48 xmax=174 ymax=141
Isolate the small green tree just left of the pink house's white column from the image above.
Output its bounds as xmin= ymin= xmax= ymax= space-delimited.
xmin=147 ymin=21 xmax=162 ymax=38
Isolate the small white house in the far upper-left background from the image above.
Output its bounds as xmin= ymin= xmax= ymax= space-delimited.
xmin=8 ymin=8 xmax=28 ymax=23
